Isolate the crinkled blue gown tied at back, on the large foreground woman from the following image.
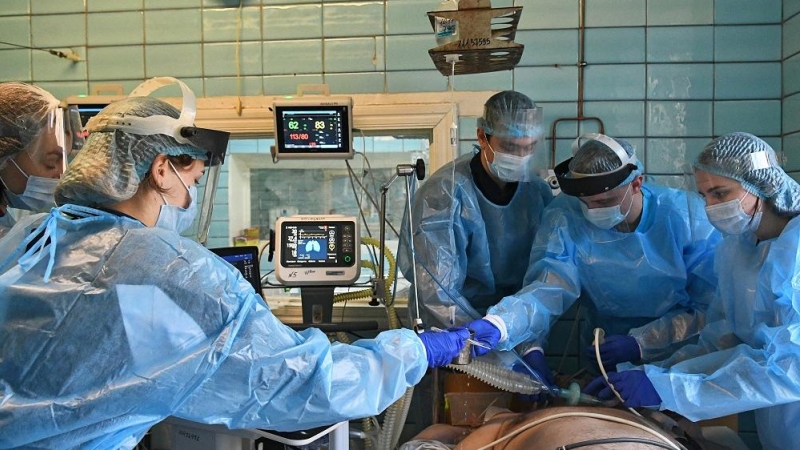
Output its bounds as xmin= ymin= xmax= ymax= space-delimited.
xmin=0 ymin=205 xmax=427 ymax=449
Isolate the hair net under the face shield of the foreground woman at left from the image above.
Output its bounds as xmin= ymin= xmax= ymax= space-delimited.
xmin=55 ymin=97 xmax=206 ymax=206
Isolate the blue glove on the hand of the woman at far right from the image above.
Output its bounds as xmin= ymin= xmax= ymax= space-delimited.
xmin=583 ymin=370 xmax=661 ymax=408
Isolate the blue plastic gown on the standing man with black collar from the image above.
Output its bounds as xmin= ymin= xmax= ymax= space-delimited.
xmin=398 ymin=154 xmax=553 ymax=327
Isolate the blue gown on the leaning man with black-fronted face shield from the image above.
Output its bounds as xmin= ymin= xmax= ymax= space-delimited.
xmin=489 ymin=184 xmax=720 ymax=360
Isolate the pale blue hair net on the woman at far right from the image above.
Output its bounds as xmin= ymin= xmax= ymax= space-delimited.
xmin=694 ymin=132 xmax=800 ymax=215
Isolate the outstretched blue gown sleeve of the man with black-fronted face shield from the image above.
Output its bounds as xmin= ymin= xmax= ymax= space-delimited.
xmin=489 ymin=195 xmax=581 ymax=350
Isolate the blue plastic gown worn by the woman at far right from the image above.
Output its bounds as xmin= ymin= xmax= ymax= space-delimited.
xmin=644 ymin=217 xmax=800 ymax=450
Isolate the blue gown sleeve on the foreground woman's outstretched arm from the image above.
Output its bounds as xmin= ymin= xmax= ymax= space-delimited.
xmin=174 ymin=303 xmax=427 ymax=431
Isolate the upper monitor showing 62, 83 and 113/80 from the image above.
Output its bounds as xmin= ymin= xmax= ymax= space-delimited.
xmin=273 ymin=102 xmax=353 ymax=159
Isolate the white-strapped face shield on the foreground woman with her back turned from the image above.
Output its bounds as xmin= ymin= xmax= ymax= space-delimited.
xmin=87 ymin=77 xmax=230 ymax=243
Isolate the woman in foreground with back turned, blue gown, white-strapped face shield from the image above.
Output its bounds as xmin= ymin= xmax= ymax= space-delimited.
xmin=0 ymin=78 xmax=468 ymax=448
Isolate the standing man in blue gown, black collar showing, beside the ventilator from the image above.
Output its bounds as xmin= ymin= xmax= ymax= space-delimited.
xmin=399 ymin=91 xmax=553 ymax=327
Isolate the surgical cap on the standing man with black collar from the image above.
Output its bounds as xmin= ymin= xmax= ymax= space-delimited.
xmin=478 ymin=91 xmax=542 ymax=138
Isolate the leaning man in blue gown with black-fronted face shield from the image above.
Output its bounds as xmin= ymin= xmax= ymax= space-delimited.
xmin=468 ymin=134 xmax=720 ymax=386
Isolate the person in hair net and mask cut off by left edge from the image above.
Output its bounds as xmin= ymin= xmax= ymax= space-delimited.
xmin=0 ymin=82 xmax=72 ymax=237
